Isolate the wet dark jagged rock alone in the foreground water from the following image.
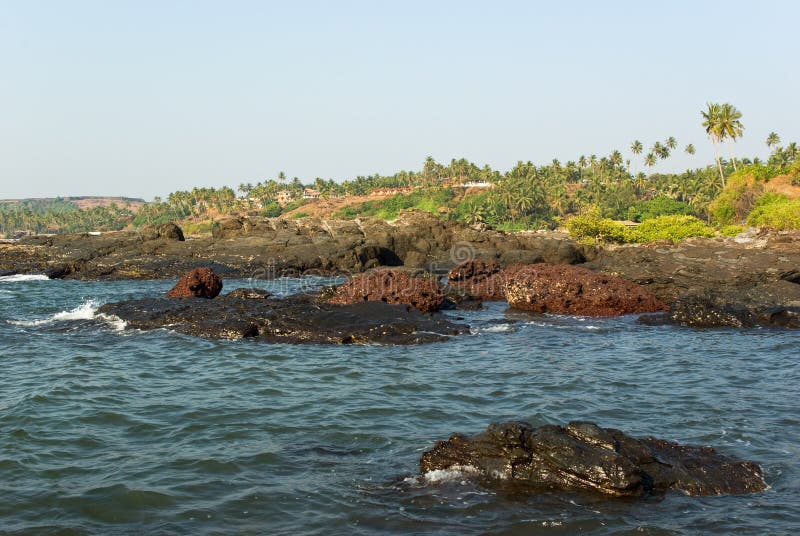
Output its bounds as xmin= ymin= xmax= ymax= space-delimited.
xmin=420 ymin=422 xmax=767 ymax=497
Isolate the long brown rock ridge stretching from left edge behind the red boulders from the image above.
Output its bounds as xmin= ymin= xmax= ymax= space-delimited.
xmin=0 ymin=212 xmax=594 ymax=279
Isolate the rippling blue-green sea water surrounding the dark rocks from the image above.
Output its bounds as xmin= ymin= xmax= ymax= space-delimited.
xmin=0 ymin=276 xmax=800 ymax=535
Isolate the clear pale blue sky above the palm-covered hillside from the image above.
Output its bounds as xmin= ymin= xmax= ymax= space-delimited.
xmin=0 ymin=0 xmax=800 ymax=199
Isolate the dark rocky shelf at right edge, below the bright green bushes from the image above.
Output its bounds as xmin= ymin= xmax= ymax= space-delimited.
xmin=586 ymin=239 xmax=800 ymax=328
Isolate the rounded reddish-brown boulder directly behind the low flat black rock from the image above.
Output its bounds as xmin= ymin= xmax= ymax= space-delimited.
xmin=329 ymin=270 xmax=444 ymax=313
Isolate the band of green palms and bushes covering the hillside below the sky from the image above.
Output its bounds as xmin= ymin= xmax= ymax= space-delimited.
xmin=0 ymin=103 xmax=800 ymax=238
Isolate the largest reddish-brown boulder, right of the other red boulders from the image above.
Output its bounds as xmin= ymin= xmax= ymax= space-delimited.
xmin=505 ymin=264 xmax=667 ymax=316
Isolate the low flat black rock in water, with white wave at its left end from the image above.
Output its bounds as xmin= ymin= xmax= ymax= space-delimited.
xmin=98 ymin=292 xmax=469 ymax=344
